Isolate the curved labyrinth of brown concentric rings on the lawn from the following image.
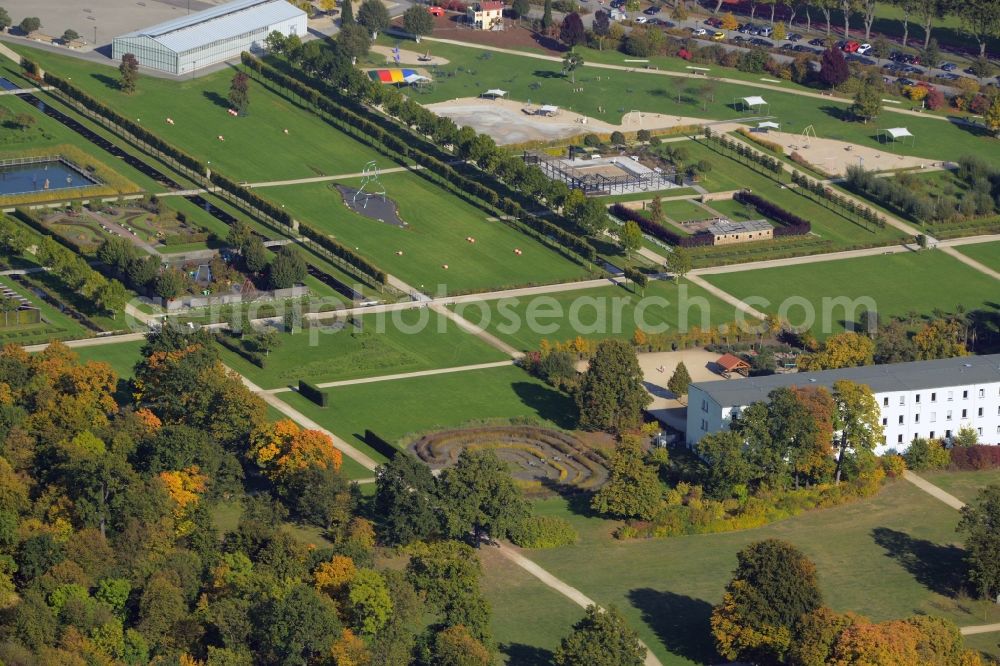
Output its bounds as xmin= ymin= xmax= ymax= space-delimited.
xmin=410 ymin=426 xmax=608 ymax=490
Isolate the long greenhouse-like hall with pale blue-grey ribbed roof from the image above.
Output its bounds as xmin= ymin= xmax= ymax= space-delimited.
xmin=112 ymin=0 xmax=307 ymax=74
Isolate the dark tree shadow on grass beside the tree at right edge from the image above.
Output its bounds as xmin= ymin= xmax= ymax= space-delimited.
xmin=872 ymin=527 xmax=966 ymax=597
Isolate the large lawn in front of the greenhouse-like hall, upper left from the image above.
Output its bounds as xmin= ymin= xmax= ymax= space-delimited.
xmin=15 ymin=46 xmax=380 ymax=182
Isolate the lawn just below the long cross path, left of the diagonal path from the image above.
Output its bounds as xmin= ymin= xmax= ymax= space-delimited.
xmin=220 ymin=308 xmax=507 ymax=388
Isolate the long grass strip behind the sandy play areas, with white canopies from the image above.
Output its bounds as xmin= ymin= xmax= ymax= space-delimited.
xmin=406 ymin=43 xmax=1000 ymax=164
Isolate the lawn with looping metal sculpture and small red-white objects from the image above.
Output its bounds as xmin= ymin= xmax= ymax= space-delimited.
xmin=267 ymin=173 xmax=585 ymax=294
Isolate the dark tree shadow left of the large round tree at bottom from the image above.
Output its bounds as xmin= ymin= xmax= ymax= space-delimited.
xmin=628 ymin=587 xmax=719 ymax=664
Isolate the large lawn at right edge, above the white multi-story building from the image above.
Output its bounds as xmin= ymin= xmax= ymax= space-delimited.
xmin=704 ymin=251 xmax=997 ymax=338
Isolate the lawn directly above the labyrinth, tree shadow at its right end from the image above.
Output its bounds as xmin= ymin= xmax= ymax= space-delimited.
xmin=278 ymin=367 xmax=575 ymax=462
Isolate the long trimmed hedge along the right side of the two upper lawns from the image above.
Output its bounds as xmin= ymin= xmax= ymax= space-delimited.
xmin=241 ymin=52 xmax=597 ymax=261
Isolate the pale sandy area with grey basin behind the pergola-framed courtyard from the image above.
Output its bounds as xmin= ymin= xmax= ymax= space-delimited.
xmin=427 ymin=97 xmax=709 ymax=145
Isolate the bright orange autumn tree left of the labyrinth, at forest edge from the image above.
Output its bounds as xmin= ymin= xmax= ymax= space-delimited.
xmin=248 ymin=419 xmax=343 ymax=481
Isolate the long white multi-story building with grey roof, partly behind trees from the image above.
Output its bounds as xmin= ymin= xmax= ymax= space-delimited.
xmin=686 ymin=354 xmax=1000 ymax=453
